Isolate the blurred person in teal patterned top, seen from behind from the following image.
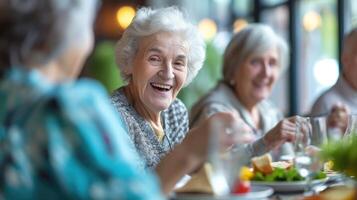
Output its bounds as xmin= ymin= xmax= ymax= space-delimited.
xmin=0 ymin=0 xmax=239 ymax=200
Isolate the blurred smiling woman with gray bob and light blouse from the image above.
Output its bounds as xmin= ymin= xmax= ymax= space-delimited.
xmin=190 ymin=24 xmax=296 ymax=160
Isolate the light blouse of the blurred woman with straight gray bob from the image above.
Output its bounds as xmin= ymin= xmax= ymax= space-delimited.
xmin=190 ymin=82 xmax=294 ymax=160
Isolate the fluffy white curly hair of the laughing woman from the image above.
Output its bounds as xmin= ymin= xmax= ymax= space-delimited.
xmin=116 ymin=7 xmax=206 ymax=86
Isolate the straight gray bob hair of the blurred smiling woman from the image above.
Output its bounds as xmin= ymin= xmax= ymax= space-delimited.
xmin=223 ymin=24 xmax=289 ymax=82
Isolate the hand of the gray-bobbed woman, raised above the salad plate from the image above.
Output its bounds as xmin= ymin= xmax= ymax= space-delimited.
xmin=263 ymin=116 xmax=299 ymax=150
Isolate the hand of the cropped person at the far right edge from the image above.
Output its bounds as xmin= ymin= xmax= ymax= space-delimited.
xmin=327 ymin=102 xmax=350 ymax=134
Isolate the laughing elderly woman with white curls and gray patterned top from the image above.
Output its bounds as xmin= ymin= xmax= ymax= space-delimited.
xmin=112 ymin=7 xmax=205 ymax=169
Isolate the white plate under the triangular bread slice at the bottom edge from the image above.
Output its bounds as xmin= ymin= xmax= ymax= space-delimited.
xmin=170 ymin=186 xmax=274 ymax=200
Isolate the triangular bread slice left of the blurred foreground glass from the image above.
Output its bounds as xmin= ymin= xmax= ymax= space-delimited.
xmin=175 ymin=163 xmax=213 ymax=194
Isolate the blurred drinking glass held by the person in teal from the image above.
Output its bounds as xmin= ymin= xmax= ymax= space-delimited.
xmin=208 ymin=119 xmax=252 ymax=196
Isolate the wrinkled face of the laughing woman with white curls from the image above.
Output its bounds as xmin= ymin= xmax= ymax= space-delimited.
xmin=129 ymin=32 xmax=188 ymax=112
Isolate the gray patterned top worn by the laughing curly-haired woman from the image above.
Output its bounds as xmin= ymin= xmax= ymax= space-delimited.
xmin=111 ymin=88 xmax=189 ymax=169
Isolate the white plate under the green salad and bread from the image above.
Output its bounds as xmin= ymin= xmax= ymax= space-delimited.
xmin=251 ymin=178 xmax=328 ymax=192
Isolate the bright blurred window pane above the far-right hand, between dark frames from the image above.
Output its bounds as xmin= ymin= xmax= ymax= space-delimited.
xmin=297 ymin=0 xmax=339 ymax=114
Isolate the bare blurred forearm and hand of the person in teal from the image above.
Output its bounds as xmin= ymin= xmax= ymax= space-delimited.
xmin=156 ymin=112 xmax=240 ymax=194
